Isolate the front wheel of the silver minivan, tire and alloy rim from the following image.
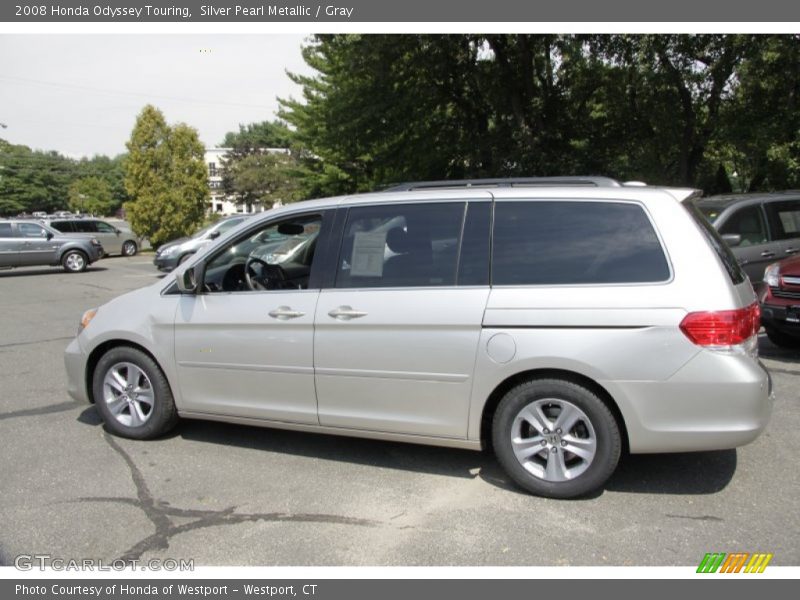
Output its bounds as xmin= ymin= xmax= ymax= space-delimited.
xmin=92 ymin=346 xmax=178 ymax=440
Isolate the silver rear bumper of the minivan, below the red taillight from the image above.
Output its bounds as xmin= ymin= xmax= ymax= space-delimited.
xmin=601 ymin=350 xmax=774 ymax=453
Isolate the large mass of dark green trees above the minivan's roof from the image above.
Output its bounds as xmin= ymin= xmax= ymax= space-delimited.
xmin=280 ymin=34 xmax=800 ymax=197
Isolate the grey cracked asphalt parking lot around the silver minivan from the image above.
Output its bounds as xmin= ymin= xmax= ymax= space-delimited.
xmin=0 ymin=255 xmax=800 ymax=566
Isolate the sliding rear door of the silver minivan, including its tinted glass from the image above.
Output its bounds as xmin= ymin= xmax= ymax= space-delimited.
xmin=314 ymin=199 xmax=491 ymax=438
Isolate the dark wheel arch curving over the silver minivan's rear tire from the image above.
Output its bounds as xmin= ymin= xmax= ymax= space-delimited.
xmin=480 ymin=369 xmax=629 ymax=453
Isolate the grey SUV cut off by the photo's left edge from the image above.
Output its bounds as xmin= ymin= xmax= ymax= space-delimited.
xmin=0 ymin=219 xmax=103 ymax=273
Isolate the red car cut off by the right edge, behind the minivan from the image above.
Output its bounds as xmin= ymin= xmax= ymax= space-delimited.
xmin=759 ymin=256 xmax=800 ymax=348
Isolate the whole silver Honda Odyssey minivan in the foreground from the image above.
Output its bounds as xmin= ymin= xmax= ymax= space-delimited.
xmin=65 ymin=178 xmax=772 ymax=498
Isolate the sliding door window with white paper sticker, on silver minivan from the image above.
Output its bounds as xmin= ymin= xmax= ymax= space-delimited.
xmin=336 ymin=202 xmax=465 ymax=288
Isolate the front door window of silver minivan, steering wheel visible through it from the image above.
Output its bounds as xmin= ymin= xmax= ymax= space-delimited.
xmin=203 ymin=214 xmax=322 ymax=292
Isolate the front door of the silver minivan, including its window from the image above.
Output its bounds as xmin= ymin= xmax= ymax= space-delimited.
xmin=175 ymin=214 xmax=327 ymax=424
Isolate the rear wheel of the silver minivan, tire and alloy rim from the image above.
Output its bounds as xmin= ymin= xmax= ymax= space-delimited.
xmin=492 ymin=379 xmax=622 ymax=498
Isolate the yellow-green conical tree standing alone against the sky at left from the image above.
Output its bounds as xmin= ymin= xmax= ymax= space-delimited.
xmin=125 ymin=105 xmax=208 ymax=246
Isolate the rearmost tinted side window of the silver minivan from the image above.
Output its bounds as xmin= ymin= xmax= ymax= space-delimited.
xmin=492 ymin=201 xmax=670 ymax=285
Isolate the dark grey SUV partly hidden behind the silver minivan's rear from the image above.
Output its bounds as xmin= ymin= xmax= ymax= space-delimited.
xmin=696 ymin=191 xmax=800 ymax=288
